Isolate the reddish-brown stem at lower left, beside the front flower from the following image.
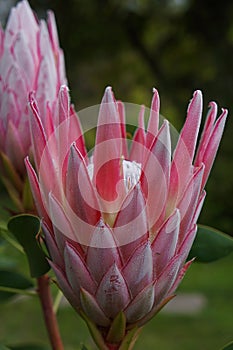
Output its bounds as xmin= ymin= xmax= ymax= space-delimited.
xmin=37 ymin=275 xmax=64 ymax=350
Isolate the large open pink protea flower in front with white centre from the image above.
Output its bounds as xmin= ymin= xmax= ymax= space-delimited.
xmin=26 ymin=86 xmax=227 ymax=349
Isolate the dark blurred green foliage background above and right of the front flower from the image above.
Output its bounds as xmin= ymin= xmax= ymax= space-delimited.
xmin=4 ymin=0 xmax=233 ymax=234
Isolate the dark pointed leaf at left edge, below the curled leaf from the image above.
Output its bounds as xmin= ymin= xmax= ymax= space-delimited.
xmin=0 ymin=270 xmax=33 ymax=302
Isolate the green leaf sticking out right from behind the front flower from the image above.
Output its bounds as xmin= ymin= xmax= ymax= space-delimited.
xmin=188 ymin=225 xmax=233 ymax=263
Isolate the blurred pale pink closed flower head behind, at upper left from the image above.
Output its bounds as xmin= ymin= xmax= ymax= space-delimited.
xmin=0 ymin=0 xmax=66 ymax=177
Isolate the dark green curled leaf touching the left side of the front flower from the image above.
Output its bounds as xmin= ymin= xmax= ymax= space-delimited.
xmin=8 ymin=215 xmax=50 ymax=277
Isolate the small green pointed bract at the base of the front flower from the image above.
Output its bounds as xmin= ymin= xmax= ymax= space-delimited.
xmin=107 ymin=311 xmax=126 ymax=344
